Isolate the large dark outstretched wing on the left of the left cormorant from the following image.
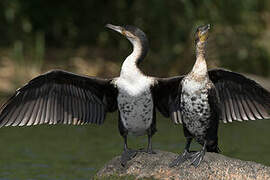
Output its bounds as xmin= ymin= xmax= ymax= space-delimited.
xmin=0 ymin=70 xmax=117 ymax=127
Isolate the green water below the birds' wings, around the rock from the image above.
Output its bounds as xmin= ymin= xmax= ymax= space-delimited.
xmin=0 ymin=114 xmax=270 ymax=180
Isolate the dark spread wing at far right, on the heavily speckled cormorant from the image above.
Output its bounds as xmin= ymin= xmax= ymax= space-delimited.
xmin=208 ymin=69 xmax=270 ymax=123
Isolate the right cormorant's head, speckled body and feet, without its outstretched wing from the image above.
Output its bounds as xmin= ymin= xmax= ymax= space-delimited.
xmin=170 ymin=25 xmax=219 ymax=167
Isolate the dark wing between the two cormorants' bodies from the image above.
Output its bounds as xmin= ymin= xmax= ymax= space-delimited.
xmin=154 ymin=76 xmax=184 ymax=123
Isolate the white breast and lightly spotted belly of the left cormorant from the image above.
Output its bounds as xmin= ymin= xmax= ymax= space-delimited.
xmin=115 ymin=76 xmax=154 ymax=135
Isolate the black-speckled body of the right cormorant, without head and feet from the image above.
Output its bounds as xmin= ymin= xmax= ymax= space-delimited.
xmin=180 ymin=50 xmax=220 ymax=149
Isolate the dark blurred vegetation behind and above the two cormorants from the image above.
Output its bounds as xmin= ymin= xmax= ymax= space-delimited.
xmin=0 ymin=0 xmax=270 ymax=94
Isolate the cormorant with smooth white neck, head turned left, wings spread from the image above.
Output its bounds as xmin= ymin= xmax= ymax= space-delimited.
xmin=0 ymin=24 xmax=181 ymax=165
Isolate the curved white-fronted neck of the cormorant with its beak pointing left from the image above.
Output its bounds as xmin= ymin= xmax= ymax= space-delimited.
xmin=120 ymin=40 xmax=148 ymax=78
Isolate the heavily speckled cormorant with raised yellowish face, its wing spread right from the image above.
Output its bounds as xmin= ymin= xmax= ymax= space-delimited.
xmin=170 ymin=25 xmax=270 ymax=167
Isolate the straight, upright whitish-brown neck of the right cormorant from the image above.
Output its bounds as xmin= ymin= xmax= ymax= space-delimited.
xmin=191 ymin=42 xmax=207 ymax=76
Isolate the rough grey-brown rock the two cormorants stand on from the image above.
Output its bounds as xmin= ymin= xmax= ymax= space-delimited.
xmin=96 ymin=150 xmax=270 ymax=180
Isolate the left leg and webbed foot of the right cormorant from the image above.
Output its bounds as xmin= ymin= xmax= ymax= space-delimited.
xmin=169 ymin=138 xmax=194 ymax=167
